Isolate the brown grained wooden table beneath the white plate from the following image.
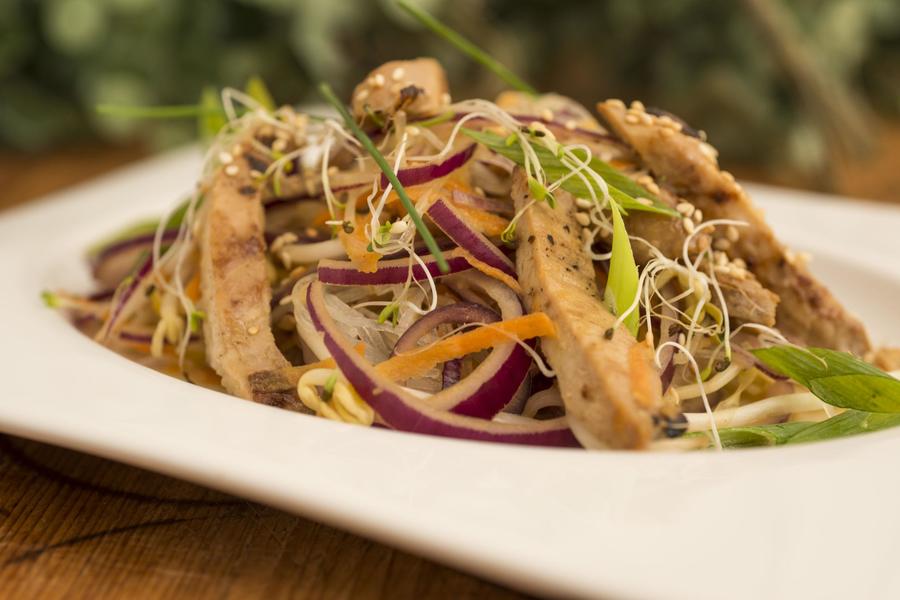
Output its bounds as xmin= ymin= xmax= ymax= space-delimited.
xmin=0 ymin=148 xmax=522 ymax=600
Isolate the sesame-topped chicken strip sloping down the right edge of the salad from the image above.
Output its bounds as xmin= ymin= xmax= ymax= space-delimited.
xmin=597 ymin=100 xmax=870 ymax=356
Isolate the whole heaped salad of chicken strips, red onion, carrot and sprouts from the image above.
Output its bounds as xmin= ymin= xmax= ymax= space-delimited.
xmin=45 ymin=2 xmax=900 ymax=450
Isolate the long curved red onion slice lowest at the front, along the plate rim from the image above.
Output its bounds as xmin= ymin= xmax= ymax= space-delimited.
xmin=306 ymin=281 xmax=579 ymax=447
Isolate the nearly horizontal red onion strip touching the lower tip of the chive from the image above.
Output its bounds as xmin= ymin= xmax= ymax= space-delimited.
xmin=318 ymin=249 xmax=472 ymax=285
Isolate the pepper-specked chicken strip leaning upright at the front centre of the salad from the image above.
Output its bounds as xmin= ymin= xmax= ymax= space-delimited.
xmin=512 ymin=168 xmax=664 ymax=448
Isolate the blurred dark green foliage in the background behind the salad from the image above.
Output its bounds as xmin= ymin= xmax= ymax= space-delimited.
xmin=0 ymin=0 xmax=900 ymax=172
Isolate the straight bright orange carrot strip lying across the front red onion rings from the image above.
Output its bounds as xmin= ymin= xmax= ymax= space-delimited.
xmin=376 ymin=312 xmax=556 ymax=381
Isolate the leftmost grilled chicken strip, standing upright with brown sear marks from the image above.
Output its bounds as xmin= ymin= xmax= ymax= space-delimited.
xmin=200 ymin=148 xmax=290 ymax=403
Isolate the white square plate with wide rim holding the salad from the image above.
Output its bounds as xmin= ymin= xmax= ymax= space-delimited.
xmin=0 ymin=150 xmax=900 ymax=599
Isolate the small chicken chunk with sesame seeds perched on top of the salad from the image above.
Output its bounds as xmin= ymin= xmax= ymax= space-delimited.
xmin=351 ymin=58 xmax=450 ymax=121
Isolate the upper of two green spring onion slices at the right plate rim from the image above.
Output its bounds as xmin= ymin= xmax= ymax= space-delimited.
xmin=753 ymin=346 xmax=900 ymax=413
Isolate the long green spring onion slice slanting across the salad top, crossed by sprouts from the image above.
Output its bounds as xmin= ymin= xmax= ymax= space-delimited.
xmin=462 ymin=127 xmax=678 ymax=217
